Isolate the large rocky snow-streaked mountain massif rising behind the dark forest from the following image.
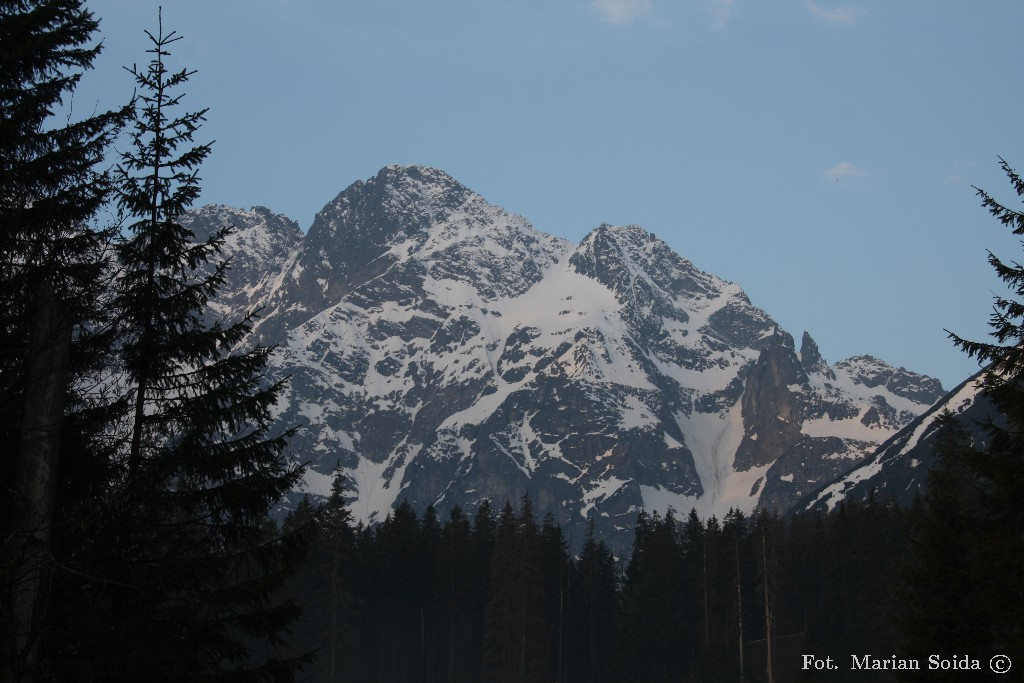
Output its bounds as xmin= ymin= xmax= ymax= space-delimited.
xmin=188 ymin=166 xmax=944 ymax=550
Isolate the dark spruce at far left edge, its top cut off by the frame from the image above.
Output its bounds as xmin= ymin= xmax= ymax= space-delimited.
xmin=0 ymin=0 xmax=128 ymax=680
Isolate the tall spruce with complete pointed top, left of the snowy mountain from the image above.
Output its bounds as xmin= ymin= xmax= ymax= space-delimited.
xmin=67 ymin=13 xmax=304 ymax=681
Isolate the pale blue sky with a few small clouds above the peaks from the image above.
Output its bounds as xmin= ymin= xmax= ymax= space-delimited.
xmin=75 ymin=0 xmax=1024 ymax=388
